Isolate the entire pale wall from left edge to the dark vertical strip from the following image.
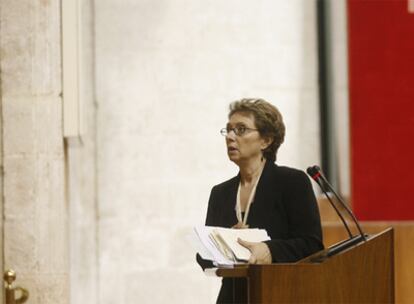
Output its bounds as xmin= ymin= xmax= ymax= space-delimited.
xmin=0 ymin=0 xmax=328 ymax=304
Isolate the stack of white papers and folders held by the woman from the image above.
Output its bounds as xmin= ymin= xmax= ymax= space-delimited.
xmin=194 ymin=226 xmax=270 ymax=267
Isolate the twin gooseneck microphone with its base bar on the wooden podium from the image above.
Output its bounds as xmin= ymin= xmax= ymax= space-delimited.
xmin=306 ymin=165 xmax=366 ymax=256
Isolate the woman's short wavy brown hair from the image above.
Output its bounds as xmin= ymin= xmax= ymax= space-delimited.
xmin=228 ymin=98 xmax=285 ymax=162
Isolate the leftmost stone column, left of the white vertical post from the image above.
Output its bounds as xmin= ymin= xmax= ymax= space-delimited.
xmin=0 ymin=0 xmax=69 ymax=304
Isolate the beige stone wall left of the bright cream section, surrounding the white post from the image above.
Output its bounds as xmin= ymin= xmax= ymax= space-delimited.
xmin=0 ymin=0 xmax=98 ymax=304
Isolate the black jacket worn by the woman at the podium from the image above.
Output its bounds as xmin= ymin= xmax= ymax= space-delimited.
xmin=197 ymin=161 xmax=323 ymax=303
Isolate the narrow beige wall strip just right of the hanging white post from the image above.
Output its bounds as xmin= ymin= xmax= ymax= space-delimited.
xmin=67 ymin=0 xmax=99 ymax=304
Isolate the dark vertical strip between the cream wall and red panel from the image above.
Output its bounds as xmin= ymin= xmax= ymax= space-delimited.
xmin=316 ymin=0 xmax=331 ymax=179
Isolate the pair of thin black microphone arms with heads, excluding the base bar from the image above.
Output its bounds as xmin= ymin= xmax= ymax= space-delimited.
xmin=306 ymin=165 xmax=366 ymax=241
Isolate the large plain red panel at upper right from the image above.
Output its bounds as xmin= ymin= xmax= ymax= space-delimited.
xmin=348 ymin=0 xmax=414 ymax=220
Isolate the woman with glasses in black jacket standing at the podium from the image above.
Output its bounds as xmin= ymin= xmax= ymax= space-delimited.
xmin=197 ymin=99 xmax=323 ymax=303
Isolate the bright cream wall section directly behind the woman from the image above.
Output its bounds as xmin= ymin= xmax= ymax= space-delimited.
xmin=96 ymin=0 xmax=319 ymax=304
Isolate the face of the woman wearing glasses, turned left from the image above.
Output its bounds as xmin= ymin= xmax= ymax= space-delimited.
xmin=226 ymin=112 xmax=269 ymax=164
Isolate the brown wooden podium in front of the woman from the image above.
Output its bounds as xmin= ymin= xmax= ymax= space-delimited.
xmin=216 ymin=228 xmax=394 ymax=304
